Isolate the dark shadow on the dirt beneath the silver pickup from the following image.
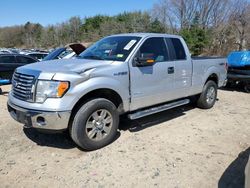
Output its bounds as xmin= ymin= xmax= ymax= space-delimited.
xmin=23 ymin=105 xmax=194 ymax=149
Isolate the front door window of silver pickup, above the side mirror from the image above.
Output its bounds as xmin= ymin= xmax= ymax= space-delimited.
xmin=137 ymin=37 xmax=168 ymax=62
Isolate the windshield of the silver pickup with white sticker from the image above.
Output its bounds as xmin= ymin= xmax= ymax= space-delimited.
xmin=79 ymin=36 xmax=141 ymax=61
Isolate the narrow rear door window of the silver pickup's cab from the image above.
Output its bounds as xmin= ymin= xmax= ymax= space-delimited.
xmin=166 ymin=38 xmax=186 ymax=60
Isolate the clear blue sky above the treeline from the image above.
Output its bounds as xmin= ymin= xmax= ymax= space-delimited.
xmin=0 ymin=0 xmax=158 ymax=27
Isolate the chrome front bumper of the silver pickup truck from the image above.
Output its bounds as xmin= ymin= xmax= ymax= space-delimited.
xmin=7 ymin=101 xmax=71 ymax=130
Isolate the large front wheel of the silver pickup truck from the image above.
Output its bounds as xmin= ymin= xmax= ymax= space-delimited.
xmin=70 ymin=98 xmax=119 ymax=150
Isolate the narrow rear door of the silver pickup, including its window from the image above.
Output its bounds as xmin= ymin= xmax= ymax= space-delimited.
xmin=165 ymin=38 xmax=193 ymax=99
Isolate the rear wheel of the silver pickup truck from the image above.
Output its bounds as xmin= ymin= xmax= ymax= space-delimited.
xmin=197 ymin=80 xmax=217 ymax=109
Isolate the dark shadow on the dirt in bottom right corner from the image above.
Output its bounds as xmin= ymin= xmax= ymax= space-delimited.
xmin=218 ymin=147 xmax=250 ymax=188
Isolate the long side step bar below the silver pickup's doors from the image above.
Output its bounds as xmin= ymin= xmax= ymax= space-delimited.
xmin=128 ymin=99 xmax=190 ymax=120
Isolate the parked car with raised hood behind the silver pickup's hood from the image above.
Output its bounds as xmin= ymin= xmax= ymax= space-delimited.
xmin=43 ymin=43 xmax=86 ymax=61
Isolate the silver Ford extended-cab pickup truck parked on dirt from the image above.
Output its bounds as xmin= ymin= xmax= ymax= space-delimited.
xmin=8 ymin=33 xmax=227 ymax=150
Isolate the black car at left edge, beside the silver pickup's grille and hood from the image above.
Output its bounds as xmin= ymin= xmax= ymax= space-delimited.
xmin=0 ymin=54 xmax=38 ymax=80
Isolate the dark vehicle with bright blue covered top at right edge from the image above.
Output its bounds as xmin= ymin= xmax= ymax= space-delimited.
xmin=227 ymin=51 xmax=250 ymax=93
